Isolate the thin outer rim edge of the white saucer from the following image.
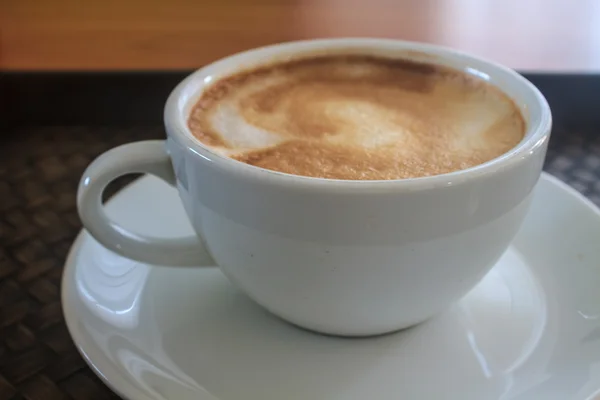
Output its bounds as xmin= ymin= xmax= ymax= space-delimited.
xmin=60 ymin=172 xmax=600 ymax=400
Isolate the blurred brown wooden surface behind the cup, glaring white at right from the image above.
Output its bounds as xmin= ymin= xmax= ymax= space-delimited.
xmin=0 ymin=0 xmax=600 ymax=72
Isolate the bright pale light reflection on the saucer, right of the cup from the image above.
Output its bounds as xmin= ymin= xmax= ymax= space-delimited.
xmin=459 ymin=251 xmax=547 ymax=377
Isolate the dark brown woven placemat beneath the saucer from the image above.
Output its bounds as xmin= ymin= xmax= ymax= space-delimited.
xmin=0 ymin=127 xmax=600 ymax=400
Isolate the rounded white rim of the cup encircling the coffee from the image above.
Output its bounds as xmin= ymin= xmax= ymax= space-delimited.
xmin=164 ymin=38 xmax=552 ymax=190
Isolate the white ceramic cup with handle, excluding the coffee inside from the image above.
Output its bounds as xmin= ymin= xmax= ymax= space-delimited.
xmin=77 ymin=39 xmax=552 ymax=336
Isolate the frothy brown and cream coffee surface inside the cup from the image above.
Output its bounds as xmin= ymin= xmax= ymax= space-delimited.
xmin=188 ymin=55 xmax=526 ymax=180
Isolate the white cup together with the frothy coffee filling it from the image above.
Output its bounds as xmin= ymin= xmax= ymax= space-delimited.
xmin=82 ymin=38 xmax=552 ymax=336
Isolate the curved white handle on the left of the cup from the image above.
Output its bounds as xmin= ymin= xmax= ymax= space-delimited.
xmin=77 ymin=140 xmax=216 ymax=266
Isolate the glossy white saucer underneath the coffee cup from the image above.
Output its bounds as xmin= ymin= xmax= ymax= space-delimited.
xmin=62 ymin=175 xmax=600 ymax=400
